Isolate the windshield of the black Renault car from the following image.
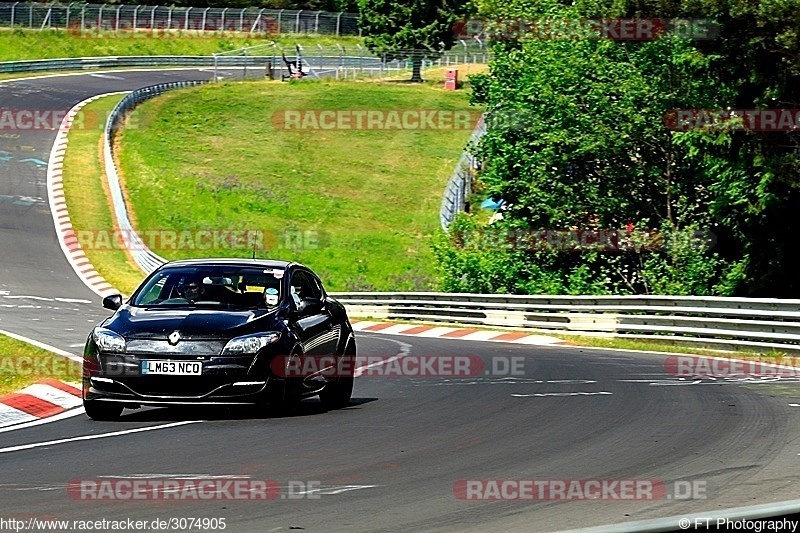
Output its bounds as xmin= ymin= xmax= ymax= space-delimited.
xmin=132 ymin=265 xmax=284 ymax=309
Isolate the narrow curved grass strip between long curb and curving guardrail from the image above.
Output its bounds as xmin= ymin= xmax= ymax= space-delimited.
xmin=63 ymin=95 xmax=144 ymax=294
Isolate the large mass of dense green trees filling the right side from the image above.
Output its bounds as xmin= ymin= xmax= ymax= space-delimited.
xmin=435 ymin=0 xmax=800 ymax=297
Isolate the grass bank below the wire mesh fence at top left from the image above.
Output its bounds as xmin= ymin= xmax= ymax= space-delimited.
xmin=0 ymin=28 xmax=363 ymax=61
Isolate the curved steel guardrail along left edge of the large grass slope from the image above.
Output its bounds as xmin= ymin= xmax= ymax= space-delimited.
xmin=103 ymin=80 xmax=199 ymax=274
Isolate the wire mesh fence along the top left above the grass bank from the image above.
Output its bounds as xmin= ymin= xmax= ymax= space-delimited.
xmin=0 ymin=2 xmax=360 ymax=37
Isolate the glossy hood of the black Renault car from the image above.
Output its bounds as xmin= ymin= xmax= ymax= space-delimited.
xmin=104 ymin=306 xmax=277 ymax=339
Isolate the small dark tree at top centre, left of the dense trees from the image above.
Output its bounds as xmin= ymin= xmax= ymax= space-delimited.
xmin=358 ymin=0 xmax=471 ymax=82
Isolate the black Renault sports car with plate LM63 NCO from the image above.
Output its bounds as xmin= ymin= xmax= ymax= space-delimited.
xmin=83 ymin=259 xmax=356 ymax=420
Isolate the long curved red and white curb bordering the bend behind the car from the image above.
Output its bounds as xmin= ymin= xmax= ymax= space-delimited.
xmin=47 ymin=91 xmax=125 ymax=296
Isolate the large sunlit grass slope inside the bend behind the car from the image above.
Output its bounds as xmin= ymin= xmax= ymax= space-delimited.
xmin=120 ymin=80 xmax=477 ymax=290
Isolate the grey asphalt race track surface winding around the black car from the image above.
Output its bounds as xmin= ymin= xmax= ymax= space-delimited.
xmin=0 ymin=70 xmax=800 ymax=532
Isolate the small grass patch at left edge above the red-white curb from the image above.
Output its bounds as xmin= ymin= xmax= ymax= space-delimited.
xmin=0 ymin=335 xmax=81 ymax=395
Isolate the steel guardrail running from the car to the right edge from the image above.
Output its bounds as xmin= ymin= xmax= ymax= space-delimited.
xmin=333 ymin=292 xmax=800 ymax=352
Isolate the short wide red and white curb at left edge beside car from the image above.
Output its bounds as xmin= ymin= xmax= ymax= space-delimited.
xmin=0 ymin=379 xmax=83 ymax=428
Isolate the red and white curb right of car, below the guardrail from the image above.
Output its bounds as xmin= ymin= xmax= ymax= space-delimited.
xmin=351 ymin=320 xmax=567 ymax=346
